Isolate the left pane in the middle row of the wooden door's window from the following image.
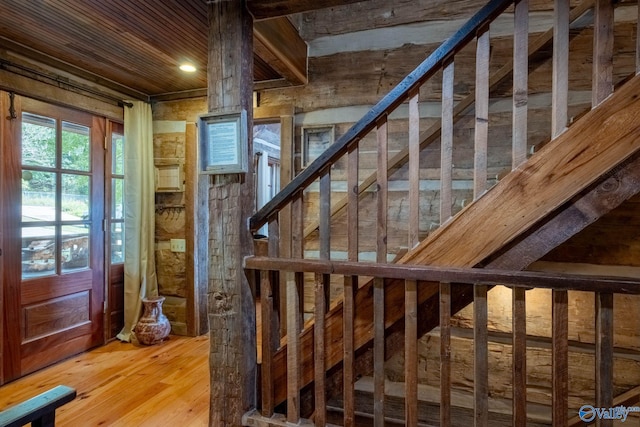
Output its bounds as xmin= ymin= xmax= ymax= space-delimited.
xmin=22 ymin=170 xmax=56 ymax=222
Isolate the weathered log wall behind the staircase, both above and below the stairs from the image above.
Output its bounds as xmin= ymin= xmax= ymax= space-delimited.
xmin=255 ymin=0 xmax=640 ymax=422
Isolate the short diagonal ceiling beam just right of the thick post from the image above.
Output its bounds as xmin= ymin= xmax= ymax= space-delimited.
xmin=253 ymin=18 xmax=307 ymax=85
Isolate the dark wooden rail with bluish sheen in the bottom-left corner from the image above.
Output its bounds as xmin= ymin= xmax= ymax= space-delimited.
xmin=0 ymin=385 xmax=76 ymax=427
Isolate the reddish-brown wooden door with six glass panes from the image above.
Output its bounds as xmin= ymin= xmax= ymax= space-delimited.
xmin=3 ymin=97 xmax=105 ymax=380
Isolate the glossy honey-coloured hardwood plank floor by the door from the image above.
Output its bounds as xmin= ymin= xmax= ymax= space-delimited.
xmin=0 ymin=335 xmax=209 ymax=427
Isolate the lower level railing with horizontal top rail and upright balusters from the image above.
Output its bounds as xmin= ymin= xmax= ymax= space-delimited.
xmin=245 ymin=257 xmax=640 ymax=426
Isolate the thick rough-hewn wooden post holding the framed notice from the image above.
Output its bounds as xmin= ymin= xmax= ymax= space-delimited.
xmin=207 ymin=1 xmax=257 ymax=426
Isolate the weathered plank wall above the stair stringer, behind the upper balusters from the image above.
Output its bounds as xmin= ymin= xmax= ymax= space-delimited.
xmin=260 ymin=6 xmax=634 ymax=264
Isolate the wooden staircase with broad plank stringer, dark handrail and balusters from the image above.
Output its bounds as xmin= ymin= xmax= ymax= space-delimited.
xmin=246 ymin=1 xmax=640 ymax=425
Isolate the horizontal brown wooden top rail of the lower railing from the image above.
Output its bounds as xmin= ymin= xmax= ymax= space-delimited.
xmin=244 ymin=256 xmax=640 ymax=294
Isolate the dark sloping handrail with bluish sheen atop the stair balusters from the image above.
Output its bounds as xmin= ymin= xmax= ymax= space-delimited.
xmin=249 ymin=0 xmax=512 ymax=231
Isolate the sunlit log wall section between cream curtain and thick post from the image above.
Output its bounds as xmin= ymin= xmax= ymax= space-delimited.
xmin=153 ymin=98 xmax=208 ymax=335
